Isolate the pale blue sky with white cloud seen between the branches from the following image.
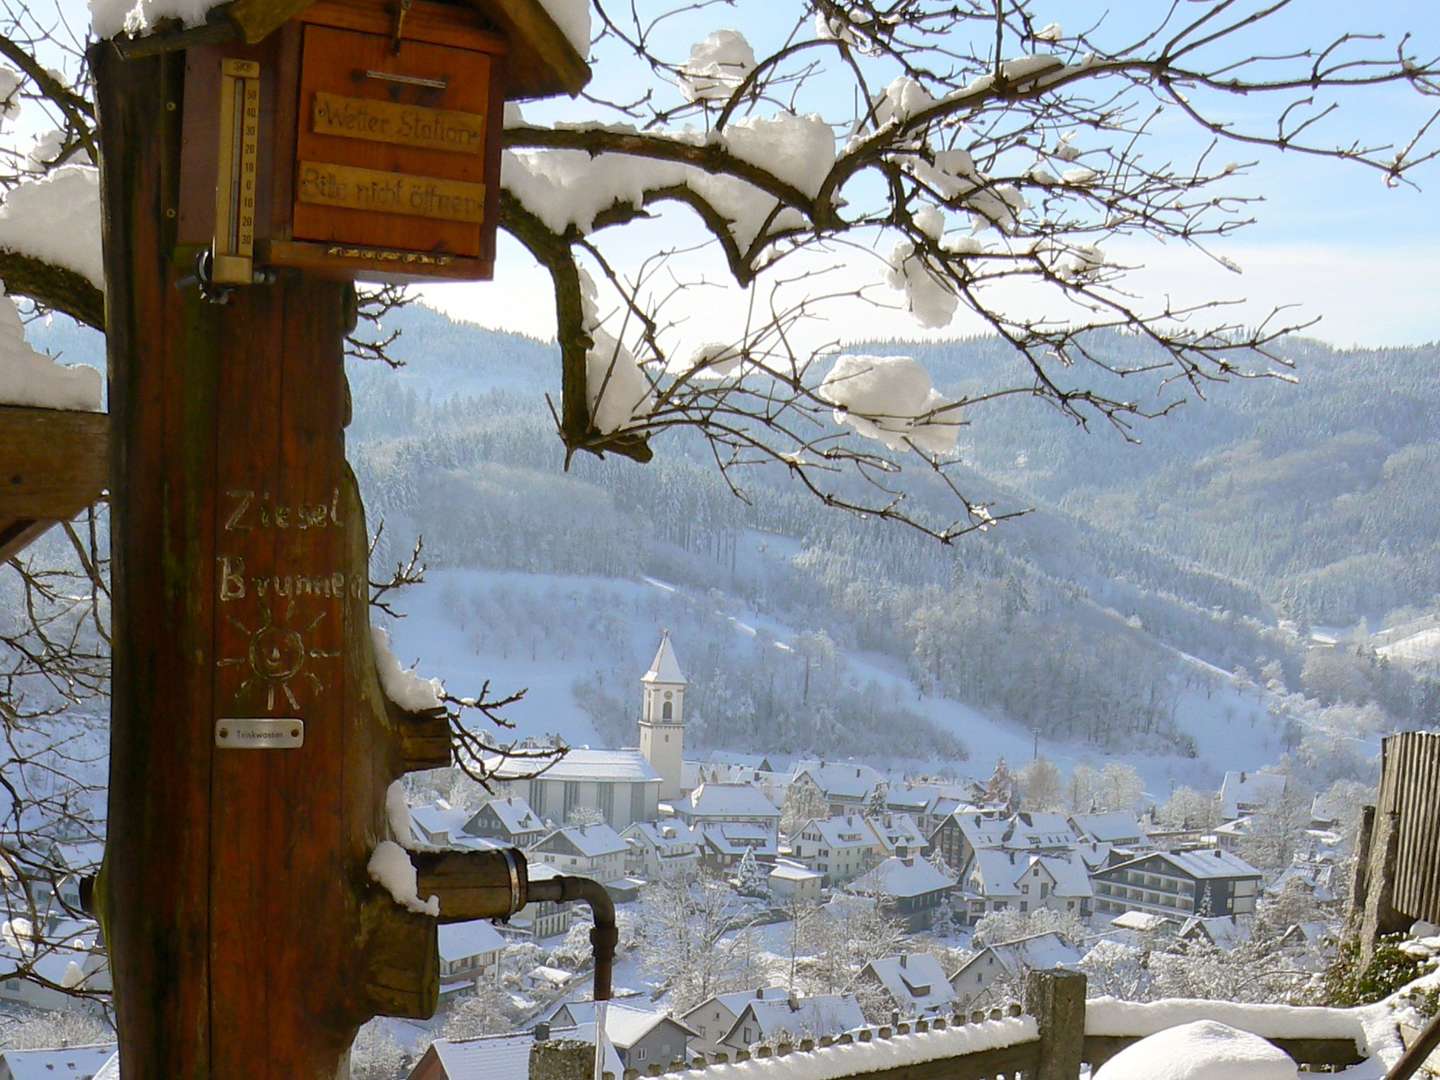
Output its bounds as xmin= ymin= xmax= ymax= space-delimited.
xmin=411 ymin=0 xmax=1440 ymax=347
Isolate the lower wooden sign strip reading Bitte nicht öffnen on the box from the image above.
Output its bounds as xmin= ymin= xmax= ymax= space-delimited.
xmin=297 ymin=161 xmax=485 ymax=225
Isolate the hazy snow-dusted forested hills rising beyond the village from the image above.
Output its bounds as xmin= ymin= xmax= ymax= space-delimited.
xmin=30 ymin=305 xmax=1440 ymax=752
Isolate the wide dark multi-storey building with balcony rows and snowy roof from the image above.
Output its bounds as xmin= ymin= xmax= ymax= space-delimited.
xmin=1092 ymin=848 xmax=1263 ymax=917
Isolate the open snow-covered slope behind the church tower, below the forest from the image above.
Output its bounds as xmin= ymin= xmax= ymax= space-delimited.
xmin=387 ymin=567 xmax=1282 ymax=801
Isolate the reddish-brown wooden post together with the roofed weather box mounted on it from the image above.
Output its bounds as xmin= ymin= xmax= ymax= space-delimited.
xmin=91 ymin=0 xmax=588 ymax=1080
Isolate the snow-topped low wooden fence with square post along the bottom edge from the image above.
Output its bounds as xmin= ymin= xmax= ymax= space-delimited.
xmin=530 ymin=971 xmax=1364 ymax=1080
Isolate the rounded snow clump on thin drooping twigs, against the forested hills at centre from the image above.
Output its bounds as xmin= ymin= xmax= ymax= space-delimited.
xmin=816 ymin=356 xmax=959 ymax=454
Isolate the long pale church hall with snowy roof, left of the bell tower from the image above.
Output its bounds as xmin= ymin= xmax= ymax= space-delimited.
xmin=484 ymin=743 xmax=661 ymax=829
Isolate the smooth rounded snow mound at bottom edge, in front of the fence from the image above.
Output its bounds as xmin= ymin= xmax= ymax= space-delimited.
xmin=1094 ymin=1020 xmax=1299 ymax=1080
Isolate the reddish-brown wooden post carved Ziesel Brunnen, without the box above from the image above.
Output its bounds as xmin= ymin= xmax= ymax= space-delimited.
xmin=91 ymin=43 xmax=437 ymax=1080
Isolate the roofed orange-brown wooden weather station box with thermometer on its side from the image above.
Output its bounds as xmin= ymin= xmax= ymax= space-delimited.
xmin=165 ymin=0 xmax=589 ymax=285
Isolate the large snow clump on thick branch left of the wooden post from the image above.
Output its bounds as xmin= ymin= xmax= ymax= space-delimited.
xmin=0 ymin=166 xmax=105 ymax=288
